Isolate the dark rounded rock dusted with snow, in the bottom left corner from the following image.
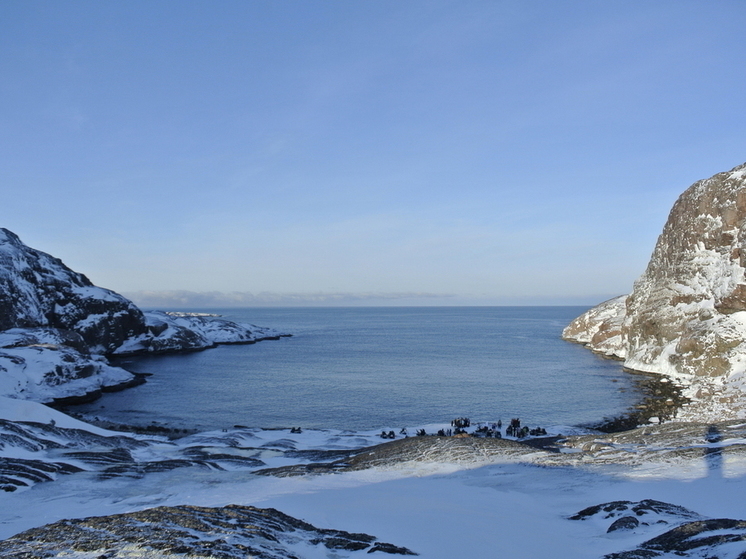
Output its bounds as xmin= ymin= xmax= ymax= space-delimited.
xmin=0 ymin=505 xmax=416 ymax=559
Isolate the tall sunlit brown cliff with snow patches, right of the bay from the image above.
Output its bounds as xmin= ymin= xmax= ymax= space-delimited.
xmin=563 ymin=164 xmax=746 ymax=417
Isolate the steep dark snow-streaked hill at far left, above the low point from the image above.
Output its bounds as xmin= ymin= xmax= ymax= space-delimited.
xmin=0 ymin=228 xmax=146 ymax=353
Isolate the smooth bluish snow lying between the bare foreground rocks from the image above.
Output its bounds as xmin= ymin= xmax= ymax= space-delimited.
xmin=0 ymin=410 xmax=746 ymax=559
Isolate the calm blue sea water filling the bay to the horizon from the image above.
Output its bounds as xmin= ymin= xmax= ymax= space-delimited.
xmin=72 ymin=307 xmax=639 ymax=429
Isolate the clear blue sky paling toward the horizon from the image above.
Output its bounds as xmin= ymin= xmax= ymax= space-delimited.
xmin=0 ymin=0 xmax=746 ymax=306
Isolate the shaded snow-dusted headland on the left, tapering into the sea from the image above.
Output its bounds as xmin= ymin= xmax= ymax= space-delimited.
xmin=0 ymin=228 xmax=283 ymax=402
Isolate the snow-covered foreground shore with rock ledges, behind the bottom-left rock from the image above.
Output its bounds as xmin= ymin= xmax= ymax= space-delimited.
xmin=0 ymin=399 xmax=746 ymax=559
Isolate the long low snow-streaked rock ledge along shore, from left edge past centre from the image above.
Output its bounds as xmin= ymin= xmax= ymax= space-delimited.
xmin=0 ymin=420 xmax=540 ymax=488
